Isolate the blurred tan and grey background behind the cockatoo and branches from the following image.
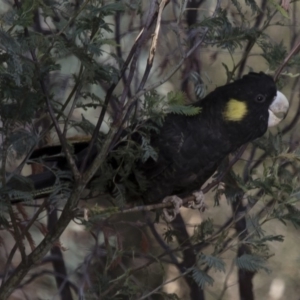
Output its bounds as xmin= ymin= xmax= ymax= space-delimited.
xmin=0 ymin=0 xmax=300 ymax=300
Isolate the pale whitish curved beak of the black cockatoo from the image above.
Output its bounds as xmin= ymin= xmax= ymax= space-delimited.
xmin=268 ymin=91 xmax=289 ymax=127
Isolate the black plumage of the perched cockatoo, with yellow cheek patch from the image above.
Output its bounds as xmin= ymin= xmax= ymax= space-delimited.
xmin=10 ymin=73 xmax=287 ymax=202
